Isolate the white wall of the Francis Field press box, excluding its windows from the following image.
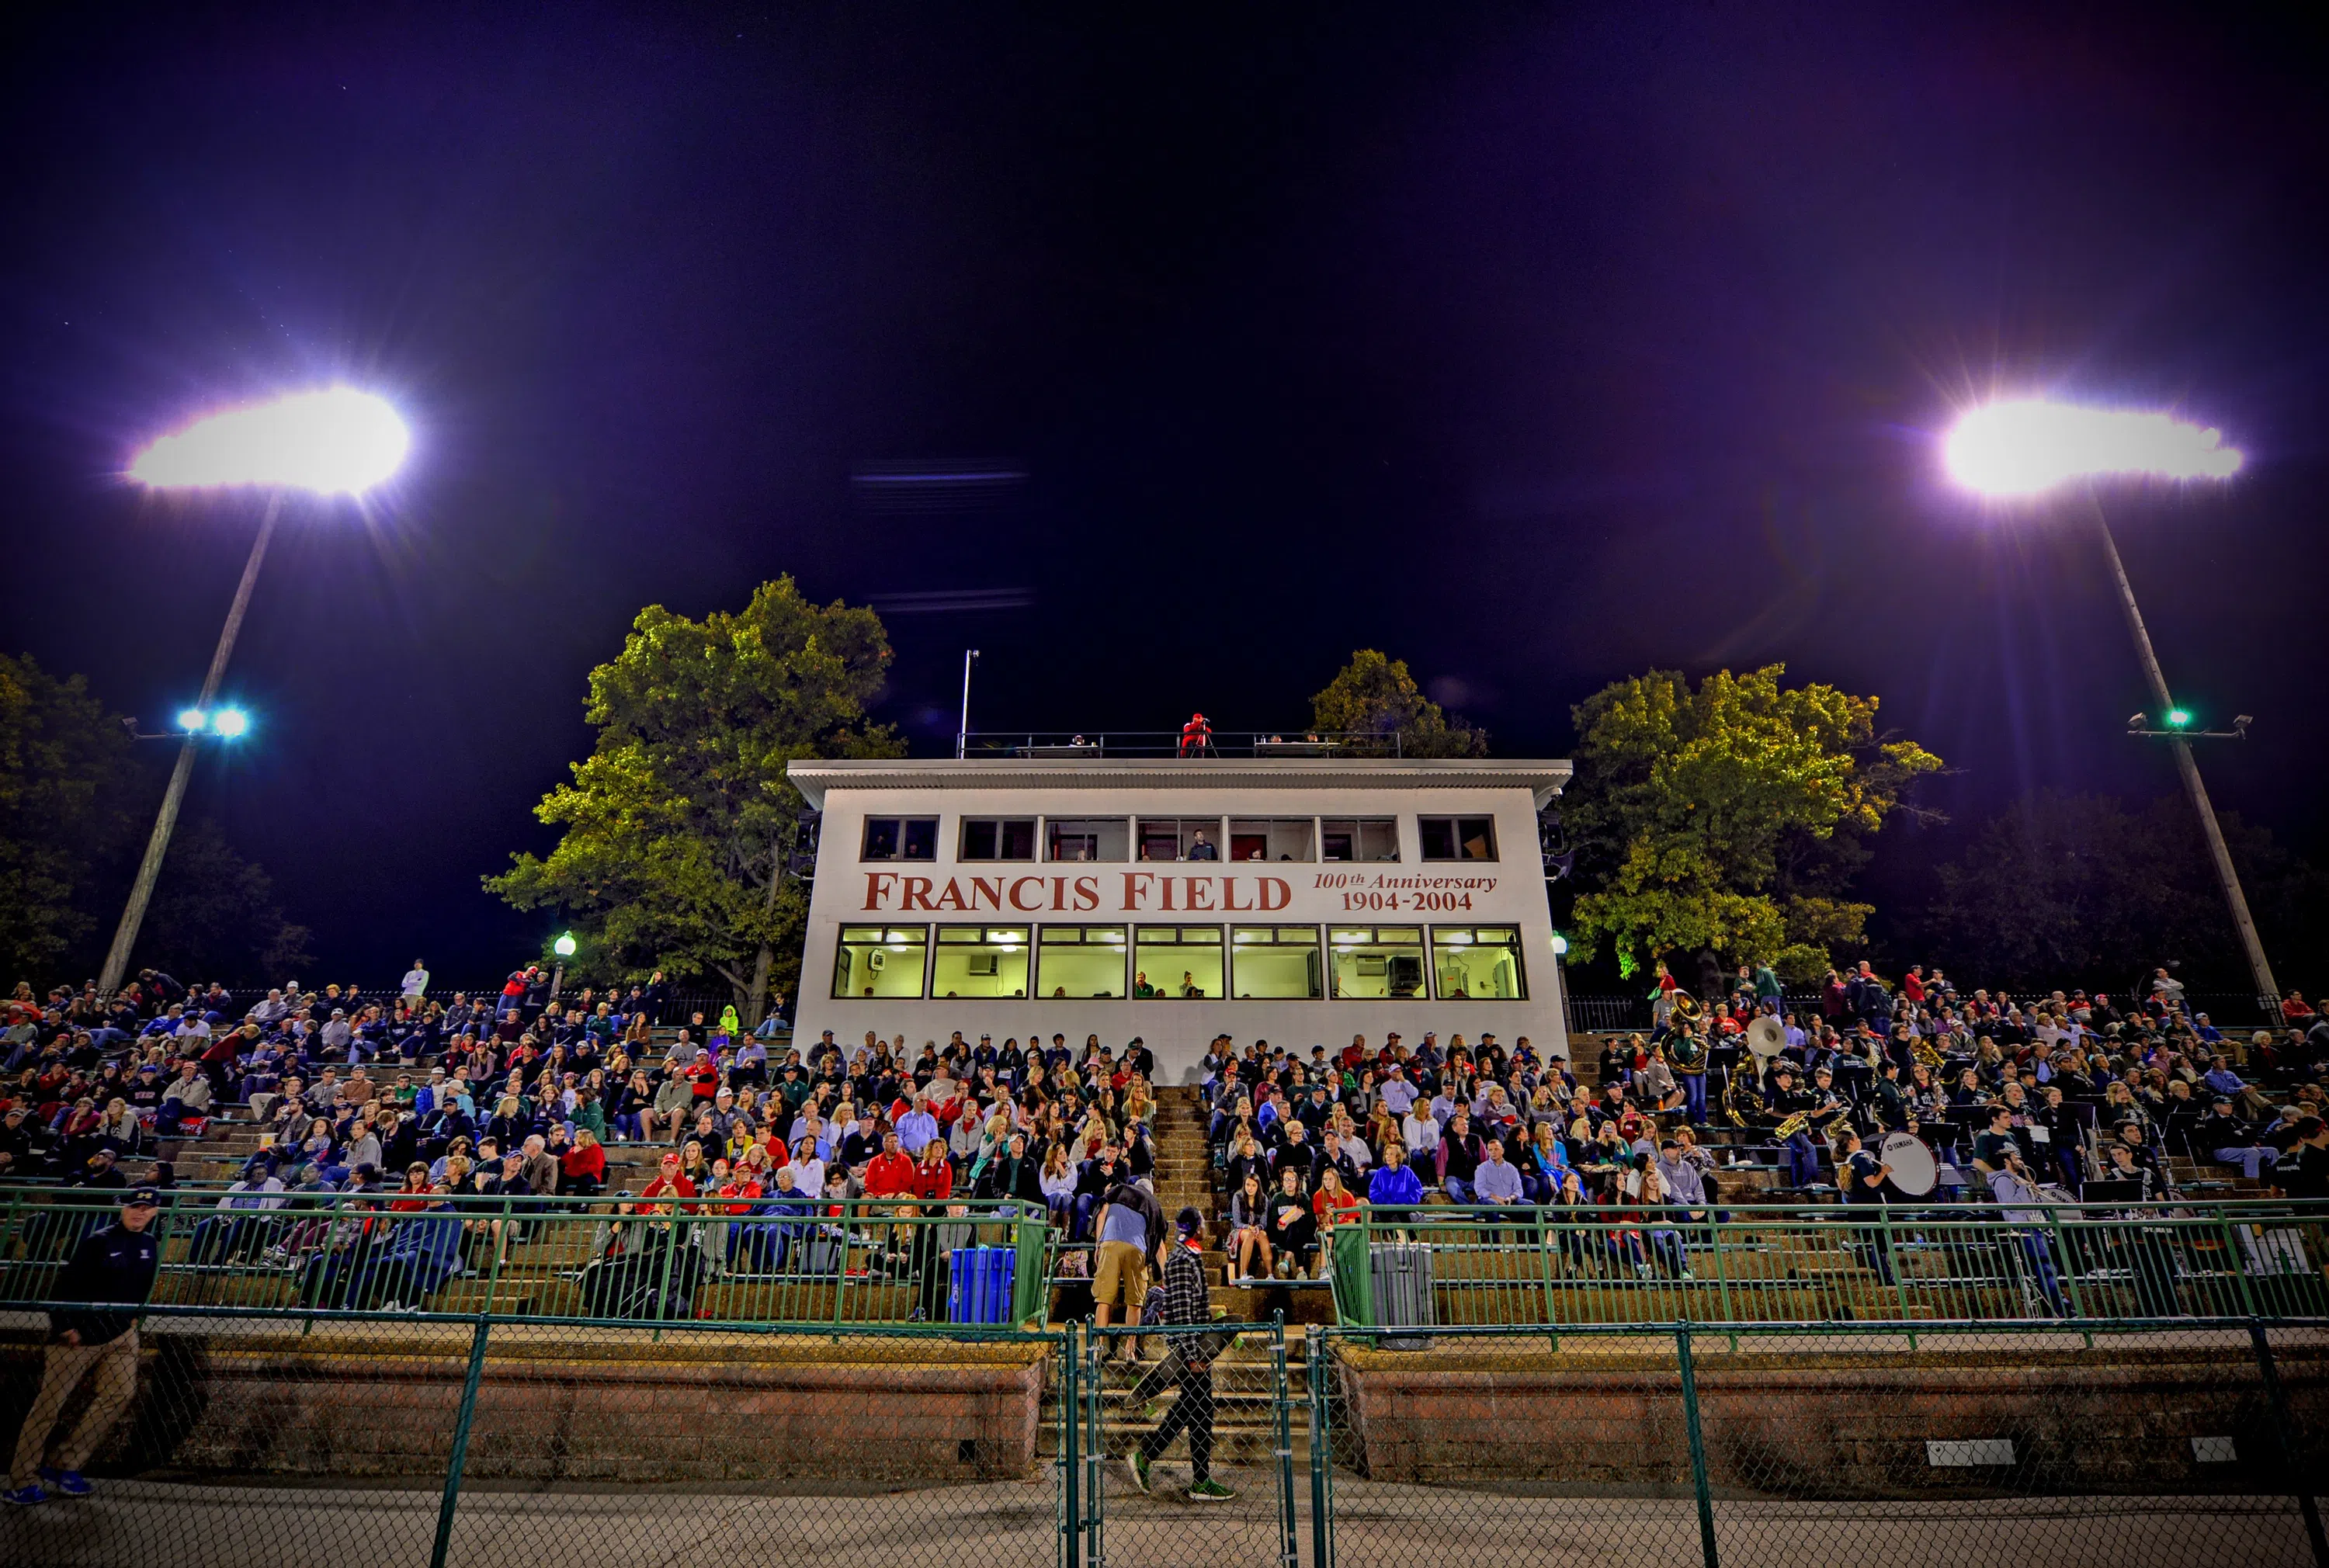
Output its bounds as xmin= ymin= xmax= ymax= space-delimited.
xmin=790 ymin=757 xmax=1570 ymax=1084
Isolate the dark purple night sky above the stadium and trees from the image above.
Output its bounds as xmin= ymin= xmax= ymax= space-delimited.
xmin=0 ymin=5 xmax=2329 ymax=983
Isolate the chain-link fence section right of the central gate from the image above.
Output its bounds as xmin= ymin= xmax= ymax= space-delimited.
xmin=1309 ymin=1321 xmax=2329 ymax=1568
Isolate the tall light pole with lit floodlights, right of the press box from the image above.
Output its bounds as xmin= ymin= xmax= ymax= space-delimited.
xmin=1942 ymin=398 xmax=2280 ymax=1021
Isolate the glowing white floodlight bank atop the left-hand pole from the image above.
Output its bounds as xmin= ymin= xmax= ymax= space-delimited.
xmin=130 ymin=387 xmax=412 ymax=496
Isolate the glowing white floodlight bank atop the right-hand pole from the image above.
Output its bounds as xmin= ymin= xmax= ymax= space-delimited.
xmin=1940 ymin=398 xmax=2240 ymax=496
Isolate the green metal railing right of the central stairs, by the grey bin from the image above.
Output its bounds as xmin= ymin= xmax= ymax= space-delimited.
xmin=1330 ymin=1202 xmax=2329 ymax=1328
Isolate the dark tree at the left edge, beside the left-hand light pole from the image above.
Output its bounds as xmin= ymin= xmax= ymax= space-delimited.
xmin=0 ymin=654 xmax=130 ymax=979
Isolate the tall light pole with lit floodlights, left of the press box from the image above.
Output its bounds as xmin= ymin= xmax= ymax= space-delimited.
xmin=98 ymin=387 xmax=412 ymax=997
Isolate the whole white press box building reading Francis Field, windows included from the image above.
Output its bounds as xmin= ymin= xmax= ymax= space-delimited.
xmin=787 ymin=748 xmax=1570 ymax=1084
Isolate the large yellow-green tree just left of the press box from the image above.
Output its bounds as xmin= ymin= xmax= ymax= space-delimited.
xmin=484 ymin=575 xmax=906 ymax=1023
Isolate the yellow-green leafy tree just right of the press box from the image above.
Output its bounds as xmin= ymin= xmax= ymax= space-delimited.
xmin=1563 ymin=664 xmax=1940 ymax=979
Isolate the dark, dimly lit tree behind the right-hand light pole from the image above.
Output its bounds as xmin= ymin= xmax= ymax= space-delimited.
xmin=1921 ymin=790 xmax=2329 ymax=990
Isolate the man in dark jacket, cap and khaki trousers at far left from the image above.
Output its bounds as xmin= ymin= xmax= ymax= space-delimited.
xmin=7 ymin=1186 xmax=161 ymax=1505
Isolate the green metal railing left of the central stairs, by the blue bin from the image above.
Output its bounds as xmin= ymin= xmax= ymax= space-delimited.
xmin=0 ymin=1188 xmax=1050 ymax=1323
